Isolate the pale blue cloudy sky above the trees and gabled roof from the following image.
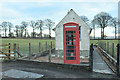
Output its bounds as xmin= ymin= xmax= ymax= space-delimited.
xmin=0 ymin=0 xmax=118 ymax=36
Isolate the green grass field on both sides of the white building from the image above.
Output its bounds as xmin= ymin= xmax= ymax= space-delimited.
xmin=2 ymin=38 xmax=118 ymax=55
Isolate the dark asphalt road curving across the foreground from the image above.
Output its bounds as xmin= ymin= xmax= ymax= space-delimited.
xmin=2 ymin=61 xmax=117 ymax=80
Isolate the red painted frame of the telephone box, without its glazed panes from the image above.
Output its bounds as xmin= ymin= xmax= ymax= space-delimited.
xmin=63 ymin=22 xmax=80 ymax=64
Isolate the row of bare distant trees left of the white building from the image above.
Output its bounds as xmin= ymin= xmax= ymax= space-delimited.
xmin=0 ymin=19 xmax=55 ymax=38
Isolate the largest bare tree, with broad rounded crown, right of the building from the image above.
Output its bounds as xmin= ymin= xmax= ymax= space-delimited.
xmin=93 ymin=12 xmax=112 ymax=39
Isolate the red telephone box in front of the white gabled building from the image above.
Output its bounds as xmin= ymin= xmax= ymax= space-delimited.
xmin=63 ymin=22 xmax=80 ymax=64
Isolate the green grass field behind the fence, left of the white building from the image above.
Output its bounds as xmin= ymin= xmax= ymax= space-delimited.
xmin=2 ymin=38 xmax=55 ymax=55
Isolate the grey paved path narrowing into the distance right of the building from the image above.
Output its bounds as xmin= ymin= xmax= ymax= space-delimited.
xmin=93 ymin=48 xmax=114 ymax=74
